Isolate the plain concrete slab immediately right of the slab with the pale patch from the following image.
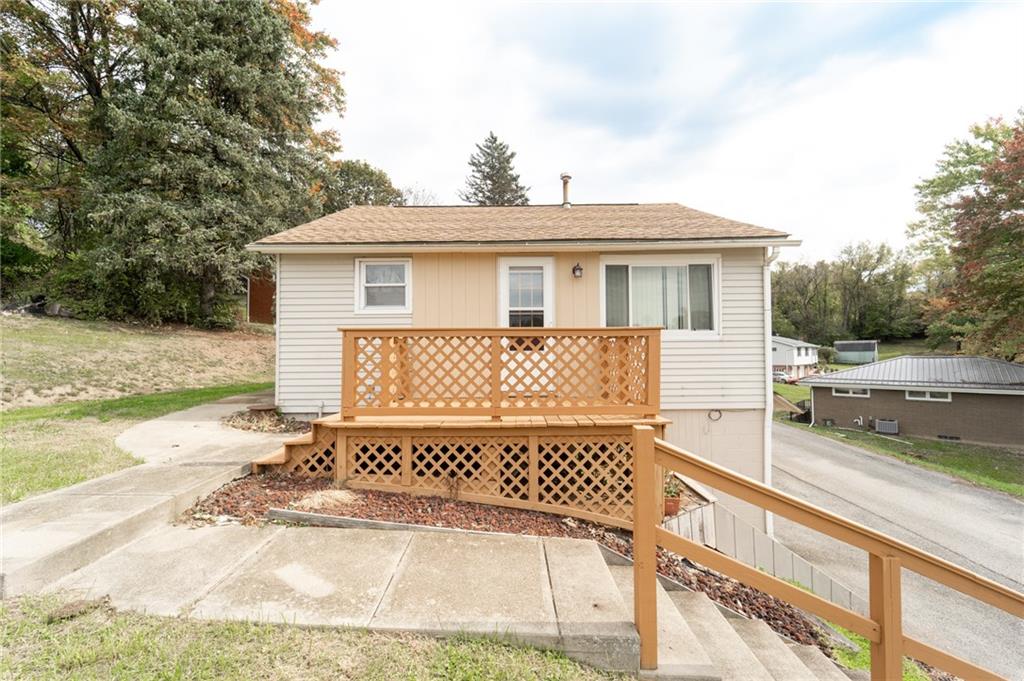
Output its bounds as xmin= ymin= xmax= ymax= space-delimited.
xmin=370 ymin=533 xmax=558 ymax=646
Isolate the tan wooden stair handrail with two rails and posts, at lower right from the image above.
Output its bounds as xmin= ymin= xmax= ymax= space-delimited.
xmin=633 ymin=426 xmax=1024 ymax=681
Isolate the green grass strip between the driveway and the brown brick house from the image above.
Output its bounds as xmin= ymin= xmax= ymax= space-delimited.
xmin=778 ymin=424 xmax=1024 ymax=498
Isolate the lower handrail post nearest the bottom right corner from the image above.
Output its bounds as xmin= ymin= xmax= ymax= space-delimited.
xmin=868 ymin=553 xmax=903 ymax=681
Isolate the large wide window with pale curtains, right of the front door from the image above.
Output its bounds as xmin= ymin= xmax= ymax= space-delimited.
xmin=604 ymin=261 xmax=717 ymax=332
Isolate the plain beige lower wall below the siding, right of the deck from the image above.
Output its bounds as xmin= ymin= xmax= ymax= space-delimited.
xmin=662 ymin=409 xmax=766 ymax=531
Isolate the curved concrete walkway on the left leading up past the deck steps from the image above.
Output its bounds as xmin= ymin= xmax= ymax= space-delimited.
xmin=0 ymin=393 xmax=289 ymax=597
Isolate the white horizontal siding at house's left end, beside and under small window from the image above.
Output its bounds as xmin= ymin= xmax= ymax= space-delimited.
xmin=275 ymin=254 xmax=415 ymax=414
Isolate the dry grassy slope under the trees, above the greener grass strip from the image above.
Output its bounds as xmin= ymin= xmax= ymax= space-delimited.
xmin=0 ymin=314 xmax=273 ymax=408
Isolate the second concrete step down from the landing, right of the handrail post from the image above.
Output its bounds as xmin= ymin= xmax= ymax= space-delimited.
xmin=670 ymin=591 xmax=774 ymax=681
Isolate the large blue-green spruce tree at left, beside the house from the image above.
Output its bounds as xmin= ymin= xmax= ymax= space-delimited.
xmin=88 ymin=0 xmax=343 ymax=326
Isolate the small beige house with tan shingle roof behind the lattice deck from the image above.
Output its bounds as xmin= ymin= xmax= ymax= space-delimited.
xmin=250 ymin=203 xmax=799 ymax=526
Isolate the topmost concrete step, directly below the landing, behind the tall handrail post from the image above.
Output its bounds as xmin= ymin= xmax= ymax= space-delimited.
xmin=608 ymin=565 xmax=722 ymax=681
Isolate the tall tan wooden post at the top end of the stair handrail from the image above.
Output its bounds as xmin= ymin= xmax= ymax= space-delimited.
xmin=633 ymin=426 xmax=657 ymax=669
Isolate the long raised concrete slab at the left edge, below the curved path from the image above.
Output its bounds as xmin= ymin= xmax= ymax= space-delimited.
xmin=0 ymin=462 xmax=249 ymax=598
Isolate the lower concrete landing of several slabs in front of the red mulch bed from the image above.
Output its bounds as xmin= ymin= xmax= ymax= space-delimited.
xmin=48 ymin=525 xmax=639 ymax=670
